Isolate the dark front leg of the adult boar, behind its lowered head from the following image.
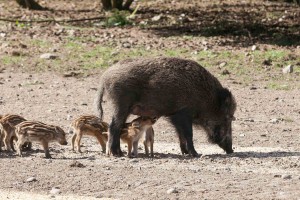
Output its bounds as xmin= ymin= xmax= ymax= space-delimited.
xmin=171 ymin=109 xmax=198 ymax=157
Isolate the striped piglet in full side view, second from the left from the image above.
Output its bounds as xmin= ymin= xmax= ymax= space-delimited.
xmin=16 ymin=121 xmax=67 ymax=158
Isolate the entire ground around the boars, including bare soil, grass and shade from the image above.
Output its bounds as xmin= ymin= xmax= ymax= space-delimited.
xmin=0 ymin=0 xmax=300 ymax=200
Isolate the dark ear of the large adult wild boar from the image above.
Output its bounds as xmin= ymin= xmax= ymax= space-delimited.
xmin=217 ymin=88 xmax=235 ymax=113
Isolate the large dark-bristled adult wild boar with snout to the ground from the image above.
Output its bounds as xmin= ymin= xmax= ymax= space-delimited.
xmin=96 ymin=57 xmax=236 ymax=156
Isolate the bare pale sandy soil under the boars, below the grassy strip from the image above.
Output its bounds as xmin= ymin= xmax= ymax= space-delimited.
xmin=0 ymin=72 xmax=300 ymax=199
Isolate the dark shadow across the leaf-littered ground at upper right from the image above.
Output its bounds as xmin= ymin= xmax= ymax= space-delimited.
xmin=141 ymin=3 xmax=300 ymax=46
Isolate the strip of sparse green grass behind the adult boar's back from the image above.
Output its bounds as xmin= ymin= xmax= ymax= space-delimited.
xmin=0 ymin=30 xmax=300 ymax=90
